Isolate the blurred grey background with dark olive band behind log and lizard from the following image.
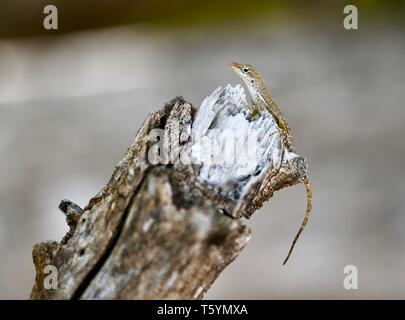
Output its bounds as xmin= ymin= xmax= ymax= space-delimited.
xmin=0 ymin=0 xmax=405 ymax=299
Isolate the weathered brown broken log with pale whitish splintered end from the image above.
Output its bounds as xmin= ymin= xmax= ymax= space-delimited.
xmin=31 ymin=85 xmax=307 ymax=299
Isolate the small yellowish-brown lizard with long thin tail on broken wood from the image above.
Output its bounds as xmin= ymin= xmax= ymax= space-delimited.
xmin=230 ymin=61 xmax=312 ymax=265
